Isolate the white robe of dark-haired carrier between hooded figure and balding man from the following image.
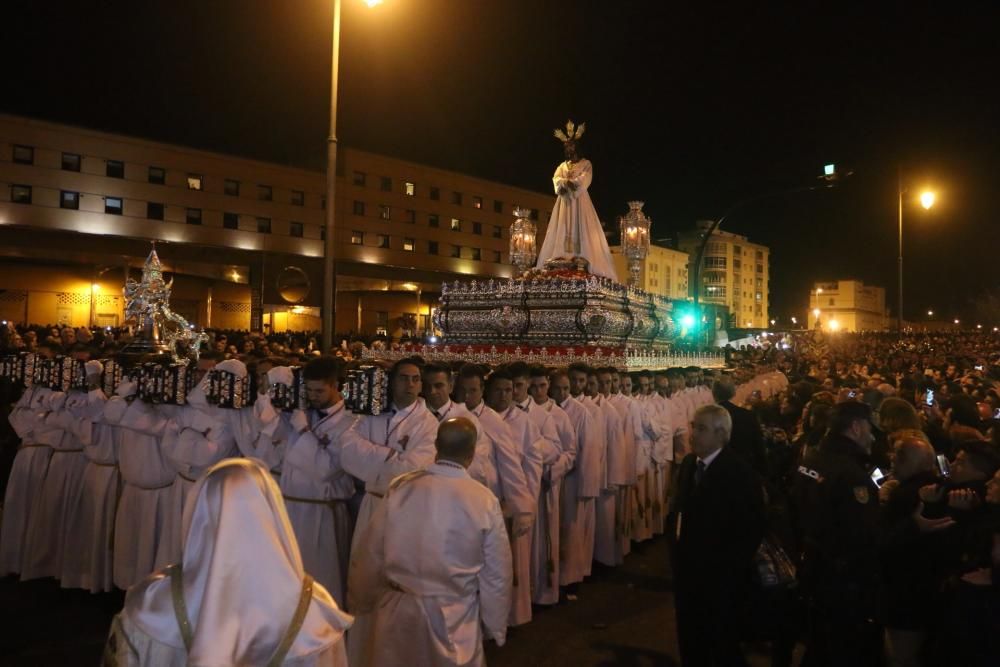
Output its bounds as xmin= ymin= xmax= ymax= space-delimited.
xmin=279 ymin=401 xmax=357 ymax=608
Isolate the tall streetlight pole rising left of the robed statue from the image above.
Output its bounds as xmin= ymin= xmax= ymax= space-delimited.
xmin=323 ymin=0 xmax=350 ymax=354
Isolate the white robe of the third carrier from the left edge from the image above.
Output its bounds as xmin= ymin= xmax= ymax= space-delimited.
xmin=60 ymin=389 xmax=121 ymax=593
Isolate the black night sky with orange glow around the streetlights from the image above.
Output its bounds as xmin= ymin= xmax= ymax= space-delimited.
xmin=0 ymin=0 xmax=1000 ymax=318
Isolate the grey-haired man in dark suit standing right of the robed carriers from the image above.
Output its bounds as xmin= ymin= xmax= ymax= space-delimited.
xmin=671 ymin=405 xmax=765 ymax=667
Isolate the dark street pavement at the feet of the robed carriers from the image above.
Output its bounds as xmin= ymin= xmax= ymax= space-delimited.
xmin=0 ymin=537 xmax=788 ymax=667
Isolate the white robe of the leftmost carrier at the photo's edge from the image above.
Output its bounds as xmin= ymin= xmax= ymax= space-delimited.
xmin=0 ymin=387 xmax=52 ymax=576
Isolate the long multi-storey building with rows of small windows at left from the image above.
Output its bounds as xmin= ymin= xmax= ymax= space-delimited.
xmin=0 ymin=115 xmax=553 ymax=340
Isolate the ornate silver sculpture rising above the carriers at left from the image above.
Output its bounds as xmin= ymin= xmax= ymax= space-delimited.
xmin=123 ymin=243 xmax=208 ymax=362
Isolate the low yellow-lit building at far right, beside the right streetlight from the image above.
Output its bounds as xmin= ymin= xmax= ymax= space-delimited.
xmin=808 ymin=280 xmax=889 ymax=331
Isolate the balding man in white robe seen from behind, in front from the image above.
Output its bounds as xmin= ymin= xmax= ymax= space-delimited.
xmin=349 ymin=418 xmax=513 ymax=667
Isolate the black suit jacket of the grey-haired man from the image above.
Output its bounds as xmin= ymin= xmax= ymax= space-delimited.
xmin=671 ymin=447 xmax=766 ymax=594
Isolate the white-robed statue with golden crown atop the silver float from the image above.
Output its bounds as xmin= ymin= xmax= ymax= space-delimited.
xmin=535 ymin=121 xmax=618 ymax=280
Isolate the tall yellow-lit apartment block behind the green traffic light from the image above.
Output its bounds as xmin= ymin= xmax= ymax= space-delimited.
xmin=677 ymin=220 xmax=771 ymax=329
